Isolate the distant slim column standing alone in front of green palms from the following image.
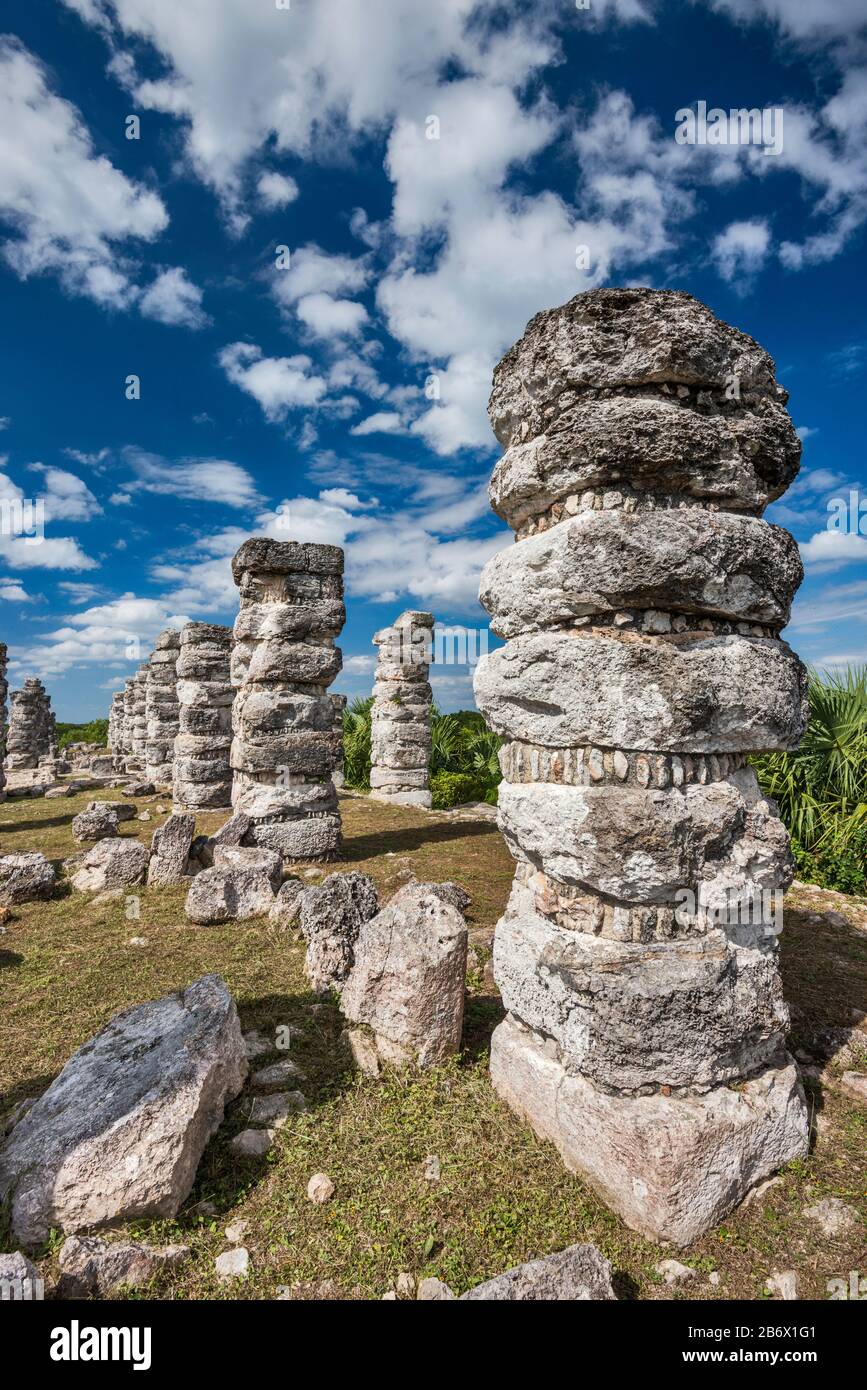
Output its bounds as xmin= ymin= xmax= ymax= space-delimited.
xmin=371 ymin=610 xmax=434 ymax=808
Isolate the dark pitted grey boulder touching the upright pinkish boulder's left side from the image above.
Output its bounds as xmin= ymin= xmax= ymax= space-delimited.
xmin=297 ymin=873 xmax=379 ymax=992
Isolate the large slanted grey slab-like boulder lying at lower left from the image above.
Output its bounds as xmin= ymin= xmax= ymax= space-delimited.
xmin=0 ymin=974 xmax=247 ymax=1248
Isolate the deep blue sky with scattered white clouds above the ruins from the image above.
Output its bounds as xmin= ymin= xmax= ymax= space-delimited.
xmin=0 ymin=0 xmax=867 ymax=720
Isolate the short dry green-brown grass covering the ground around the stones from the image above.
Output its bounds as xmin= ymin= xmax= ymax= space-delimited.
xmin=0 ymin=791 xmax=867 ymax=1298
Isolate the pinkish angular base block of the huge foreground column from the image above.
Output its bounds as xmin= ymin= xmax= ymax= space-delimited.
xmin=490 ymin=1015 xmax=809 ymax=1245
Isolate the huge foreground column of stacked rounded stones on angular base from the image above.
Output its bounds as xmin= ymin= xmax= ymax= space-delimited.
xmin=475 ymin=289 xmax=807 ymax=1244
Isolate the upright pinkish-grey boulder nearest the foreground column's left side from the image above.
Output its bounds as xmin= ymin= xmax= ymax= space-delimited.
xmin=340 ymin=885 xmax=467 ymax=1066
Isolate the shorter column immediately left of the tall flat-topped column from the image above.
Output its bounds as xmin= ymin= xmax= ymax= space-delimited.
xmin=172 ymin=623 xmax=235 ymax=810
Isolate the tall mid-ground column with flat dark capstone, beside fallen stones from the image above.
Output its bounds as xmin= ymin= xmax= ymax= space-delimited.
xmin=232 ymin=538 xmax=346 ymax=859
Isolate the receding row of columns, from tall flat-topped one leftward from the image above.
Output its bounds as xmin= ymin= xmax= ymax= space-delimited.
xmin=108 ymin=538 xmax=377 ymax=859
